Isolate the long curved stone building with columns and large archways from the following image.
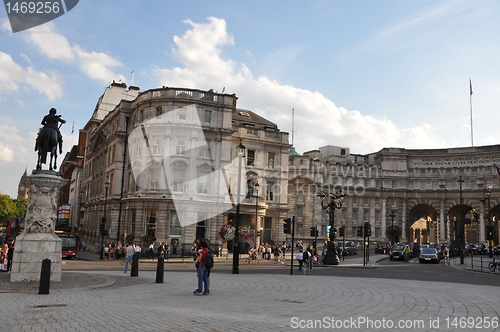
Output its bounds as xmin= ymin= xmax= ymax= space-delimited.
xmin=288 ymin=145 xmax=500 ymax=244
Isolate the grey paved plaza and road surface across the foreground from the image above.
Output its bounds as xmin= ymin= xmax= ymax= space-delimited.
xmin=0 ymin=254 xmax=500 ymax=332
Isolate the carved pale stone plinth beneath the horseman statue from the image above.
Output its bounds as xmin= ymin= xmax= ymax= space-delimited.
xmin=10 ymin=171 xmax=68 ymax=282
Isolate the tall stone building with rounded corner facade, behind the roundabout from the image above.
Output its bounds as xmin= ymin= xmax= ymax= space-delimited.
xmin=80 ymin=84 xmax=290 ymax=251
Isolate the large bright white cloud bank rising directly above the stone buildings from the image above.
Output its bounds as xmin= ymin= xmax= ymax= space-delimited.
xmin=155 ymin=17 xmax=442 ymax=153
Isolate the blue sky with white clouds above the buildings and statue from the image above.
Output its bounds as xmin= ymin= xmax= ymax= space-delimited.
xmin=0 ymin=0 xmax=500 ymax=198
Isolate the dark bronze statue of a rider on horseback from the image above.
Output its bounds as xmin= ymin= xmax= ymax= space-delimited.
xmin=35 ymin=108 xmax=66 ymax=171
